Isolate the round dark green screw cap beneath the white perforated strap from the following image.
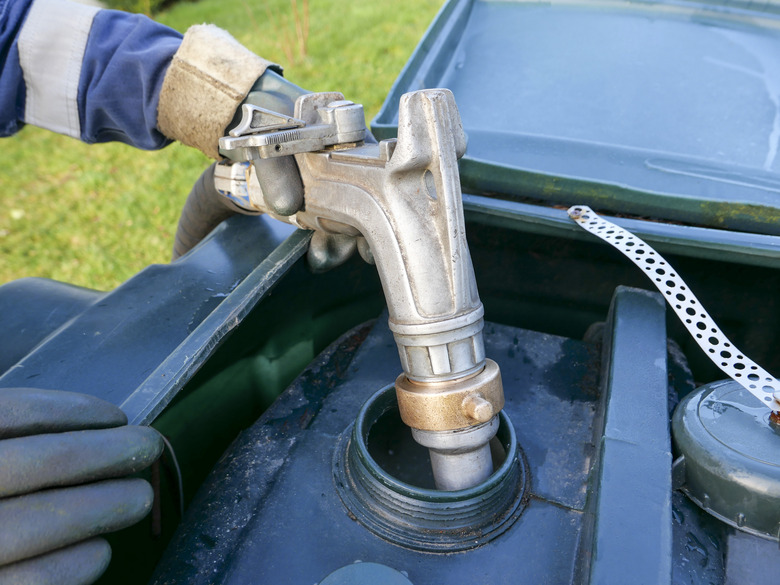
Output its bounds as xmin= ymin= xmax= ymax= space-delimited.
xmin=672 ymin=380 xmax=780 ymax=541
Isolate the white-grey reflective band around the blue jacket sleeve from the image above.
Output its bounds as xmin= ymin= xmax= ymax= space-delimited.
xmin=18 ymin=0 xmax=99 ymax=138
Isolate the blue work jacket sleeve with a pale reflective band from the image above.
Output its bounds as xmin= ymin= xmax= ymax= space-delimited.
xmin=0 ymin=0 xmax=181 ymax=149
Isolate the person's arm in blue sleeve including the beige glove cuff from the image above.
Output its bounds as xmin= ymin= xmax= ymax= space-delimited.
xmin=0 ymin=0 xmax=280 ymax=158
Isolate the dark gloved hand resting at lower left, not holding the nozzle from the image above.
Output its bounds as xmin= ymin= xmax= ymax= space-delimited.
xmin=0 ymin=388 xmax=163 ymax=585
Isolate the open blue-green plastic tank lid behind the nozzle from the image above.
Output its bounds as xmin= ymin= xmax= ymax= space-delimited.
xmin=372 ymin=0 xmax=780 ymax=240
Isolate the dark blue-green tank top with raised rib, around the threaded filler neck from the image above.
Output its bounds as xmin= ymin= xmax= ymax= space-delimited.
xmin=152 ymin=288 xmax=778 ymax=585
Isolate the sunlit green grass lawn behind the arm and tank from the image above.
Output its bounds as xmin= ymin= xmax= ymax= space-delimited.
xmin=0 ymin=0 xmax=442 ymax=290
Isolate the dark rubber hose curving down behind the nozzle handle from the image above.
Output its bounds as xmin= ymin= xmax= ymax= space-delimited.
xmin=171 ymin=163 xmax=260 ymax=260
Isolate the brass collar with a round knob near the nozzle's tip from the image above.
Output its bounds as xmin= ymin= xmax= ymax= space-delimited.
xmin=395 ymin=359 xmax=504 ymax=431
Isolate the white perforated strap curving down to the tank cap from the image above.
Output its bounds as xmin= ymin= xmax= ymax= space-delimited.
xmin=569 ymin=205 xmax=780 ymax=411
